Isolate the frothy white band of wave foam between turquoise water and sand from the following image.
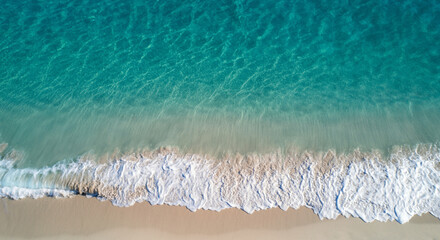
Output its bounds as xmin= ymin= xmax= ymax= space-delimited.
xmin=0 ymin=146 xmax=440 ymax=223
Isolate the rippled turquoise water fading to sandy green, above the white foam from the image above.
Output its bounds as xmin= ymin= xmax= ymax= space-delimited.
xmin=0 ymin=0 xmax=440 ymax=166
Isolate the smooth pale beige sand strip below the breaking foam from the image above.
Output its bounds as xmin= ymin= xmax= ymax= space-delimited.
xmin=0 ymin=196 xmax=440 ymax=240
